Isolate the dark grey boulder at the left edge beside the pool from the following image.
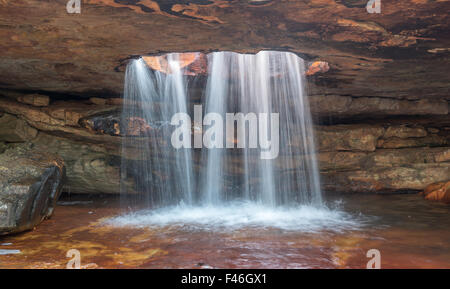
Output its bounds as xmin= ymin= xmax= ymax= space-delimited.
xmin=0 ymin=144 xmax=65 ymax=235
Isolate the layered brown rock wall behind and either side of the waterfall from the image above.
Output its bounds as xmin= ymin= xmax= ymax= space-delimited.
xmin=0 ymin=96 xmax=450 ymax=193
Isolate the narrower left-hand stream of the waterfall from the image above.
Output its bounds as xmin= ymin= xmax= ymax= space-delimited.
xmin=121 ymin=53 xmax=194 ymax=206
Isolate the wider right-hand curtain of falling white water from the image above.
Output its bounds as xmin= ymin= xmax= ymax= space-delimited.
xmin=201 ymin=51 xmax=322 ymax=206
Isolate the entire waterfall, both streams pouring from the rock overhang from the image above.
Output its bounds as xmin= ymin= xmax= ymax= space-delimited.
xmin=121 ymin=51 xmax=322 ymax=207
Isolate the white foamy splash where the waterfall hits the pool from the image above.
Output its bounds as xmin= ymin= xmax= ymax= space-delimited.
xmin=107 ymin=202 xmax=361 ymax=232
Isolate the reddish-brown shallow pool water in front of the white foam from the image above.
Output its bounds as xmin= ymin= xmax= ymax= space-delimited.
xmin=0 ymin=195 xmax=450 ymax=268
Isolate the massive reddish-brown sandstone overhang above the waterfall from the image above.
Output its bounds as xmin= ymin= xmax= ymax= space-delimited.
xmin=0 ymin=0 xmax=450 ymax=101
